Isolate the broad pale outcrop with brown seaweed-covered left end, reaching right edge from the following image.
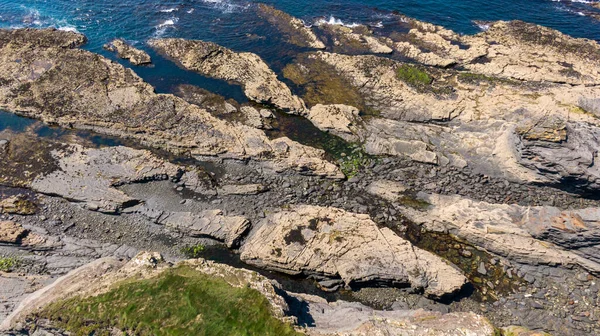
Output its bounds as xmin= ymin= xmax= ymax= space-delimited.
xmin=284 ymin=52 xmax=600 ymax=190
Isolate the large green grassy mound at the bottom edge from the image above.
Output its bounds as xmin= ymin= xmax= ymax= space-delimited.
xmin=37 ymin=266 xmax=298 ymax=336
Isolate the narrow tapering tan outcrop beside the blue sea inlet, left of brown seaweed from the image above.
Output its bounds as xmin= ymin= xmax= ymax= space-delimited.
xmin=148 ymin=38 xmax=305 ymax=112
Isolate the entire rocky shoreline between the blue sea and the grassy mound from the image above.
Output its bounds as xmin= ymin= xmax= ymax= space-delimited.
xmin=0 ymin=5 xmax=600 ymax=335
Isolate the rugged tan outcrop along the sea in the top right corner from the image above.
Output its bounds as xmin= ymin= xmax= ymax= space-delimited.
xmin=392 ymin=17 xmax=600 ymax=85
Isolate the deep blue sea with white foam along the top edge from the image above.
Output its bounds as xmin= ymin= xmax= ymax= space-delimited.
xmin=0 ymin=0 xmax=600 ymax=127
